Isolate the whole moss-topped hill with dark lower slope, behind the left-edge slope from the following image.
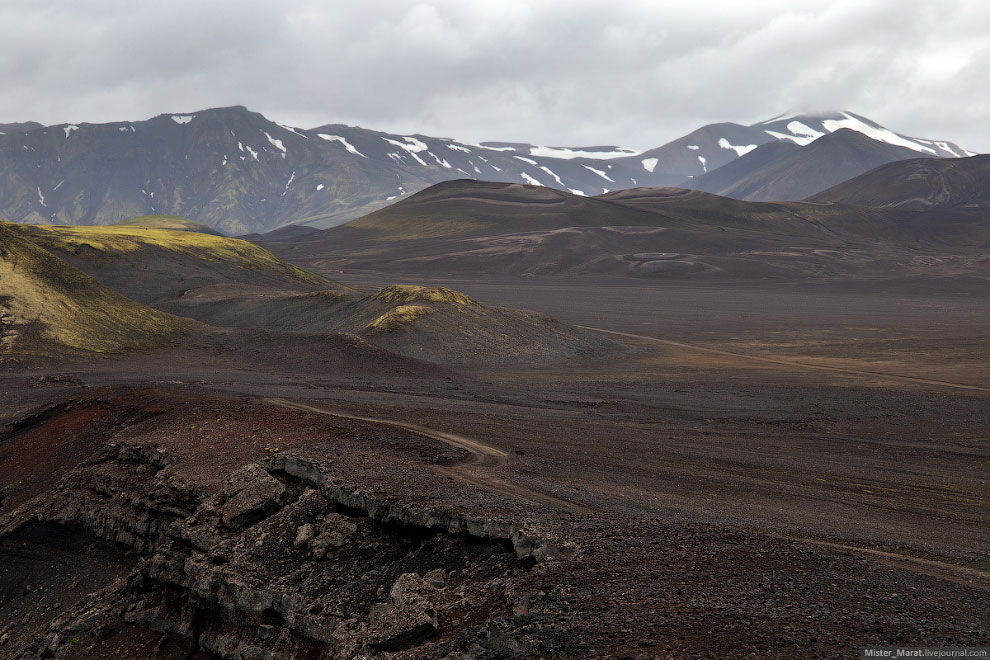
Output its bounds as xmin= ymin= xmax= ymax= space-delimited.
xmin=6 ymin=225 xmax=346 ymax=305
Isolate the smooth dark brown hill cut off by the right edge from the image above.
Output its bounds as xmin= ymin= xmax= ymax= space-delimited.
xmin=808 ymin=156 xmax=990 ymax=212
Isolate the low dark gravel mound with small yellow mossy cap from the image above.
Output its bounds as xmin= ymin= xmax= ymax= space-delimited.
xmin=161 ymin=285 xmax=617 ymax=365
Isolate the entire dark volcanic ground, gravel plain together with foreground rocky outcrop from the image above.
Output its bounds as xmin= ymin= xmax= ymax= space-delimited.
xmin=0 ymin=264 xmax=990 ymax=660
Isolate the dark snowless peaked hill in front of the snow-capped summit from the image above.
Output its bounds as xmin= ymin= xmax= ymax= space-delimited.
xmin=683 ymin=128 xmax=935 ymax=201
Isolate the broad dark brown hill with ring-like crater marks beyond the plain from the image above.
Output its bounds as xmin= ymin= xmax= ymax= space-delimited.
xmin=263 ymin=180 xmax=990 ymax=281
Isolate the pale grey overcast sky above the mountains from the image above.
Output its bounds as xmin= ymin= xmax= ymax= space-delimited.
xmin=0 ymin=0 xmax=990 ymax=152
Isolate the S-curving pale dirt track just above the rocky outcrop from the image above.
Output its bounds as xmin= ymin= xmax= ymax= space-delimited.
xmin=265 ymin=398 xmax=591 ymax=513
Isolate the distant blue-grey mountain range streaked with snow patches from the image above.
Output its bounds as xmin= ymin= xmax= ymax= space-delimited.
xmin=0 ymin=106 xmax=972 ymax=234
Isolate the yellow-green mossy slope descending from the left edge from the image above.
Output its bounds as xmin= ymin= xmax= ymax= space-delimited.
xmin=0 ymin=223 xmax=195 ymax=353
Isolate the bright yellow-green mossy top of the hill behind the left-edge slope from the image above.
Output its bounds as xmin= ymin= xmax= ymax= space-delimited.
xmin=15 ymin=225 xmax=330 ymax=285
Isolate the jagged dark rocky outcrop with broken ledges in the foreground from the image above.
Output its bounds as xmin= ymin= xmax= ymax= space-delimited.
xmin=0 ymin=442 xmax=571 ymax=660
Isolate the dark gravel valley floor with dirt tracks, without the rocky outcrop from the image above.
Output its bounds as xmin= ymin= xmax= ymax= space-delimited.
xmin=0 ymin=274 xmax=990 ymax=659
